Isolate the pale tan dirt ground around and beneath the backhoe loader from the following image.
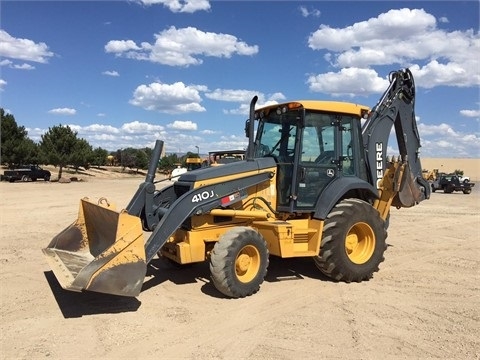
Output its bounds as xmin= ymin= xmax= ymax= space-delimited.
xmin=0 ymin=171 xmax=480 ymax=360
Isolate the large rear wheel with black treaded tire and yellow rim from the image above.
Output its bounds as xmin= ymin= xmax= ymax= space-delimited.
xmin=314 ymin=199 xmax=387 ymax=283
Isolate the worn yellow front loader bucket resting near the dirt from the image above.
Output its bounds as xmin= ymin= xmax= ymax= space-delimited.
xmin=43 ymin=198 xmax=147 ymax=296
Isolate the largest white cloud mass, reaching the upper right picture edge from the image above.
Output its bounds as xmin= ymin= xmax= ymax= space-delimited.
xmin=308 ymin=8 xmax=480 ymax=88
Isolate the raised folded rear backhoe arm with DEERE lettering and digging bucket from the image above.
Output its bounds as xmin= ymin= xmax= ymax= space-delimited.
xmin=362 ymin=69 xmax=430 ymax=208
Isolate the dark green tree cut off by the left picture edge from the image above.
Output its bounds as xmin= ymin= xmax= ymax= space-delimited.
xmin=0 ymin=108 xmax=40 ymax=167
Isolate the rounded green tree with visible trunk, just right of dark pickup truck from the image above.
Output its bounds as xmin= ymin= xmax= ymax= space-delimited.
xmin=40 ymin=124 xmax=78 ymax=179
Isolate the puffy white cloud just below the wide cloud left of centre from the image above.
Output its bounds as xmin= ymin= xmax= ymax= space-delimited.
xmin=130 ymin=82 xmax=207 ymax=114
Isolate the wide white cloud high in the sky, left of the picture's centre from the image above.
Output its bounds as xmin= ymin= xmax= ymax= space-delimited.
xmin=105 ymin=26 xmax=258 ymax=67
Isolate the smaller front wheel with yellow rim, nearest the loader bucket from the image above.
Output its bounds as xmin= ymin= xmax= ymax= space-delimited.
xmin=210 ymin=226 xmax=269 ymax=298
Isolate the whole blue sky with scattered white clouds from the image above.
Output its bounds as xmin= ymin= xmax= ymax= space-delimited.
xmin=0 ymin=0 xmax=480 ymax=158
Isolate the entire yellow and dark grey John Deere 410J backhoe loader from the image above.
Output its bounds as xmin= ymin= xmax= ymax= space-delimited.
xmin=43 ymin=69 xmax=430 ymax=298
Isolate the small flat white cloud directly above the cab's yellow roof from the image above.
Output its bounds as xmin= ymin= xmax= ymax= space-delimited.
xmin=307 ymin=68 xmax=389 ymax=97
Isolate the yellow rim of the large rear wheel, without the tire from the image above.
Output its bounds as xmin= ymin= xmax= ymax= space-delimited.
xmin=345 ymin=223 xmax=375 ymax=264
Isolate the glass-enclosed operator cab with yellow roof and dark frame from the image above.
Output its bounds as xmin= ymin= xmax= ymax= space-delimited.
xmin=254 ymin=101 xmax=368 ymax=212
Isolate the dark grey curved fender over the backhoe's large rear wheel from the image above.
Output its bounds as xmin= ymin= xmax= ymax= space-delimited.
xmin=313 ymin=177 xmax=378 ymax=220
